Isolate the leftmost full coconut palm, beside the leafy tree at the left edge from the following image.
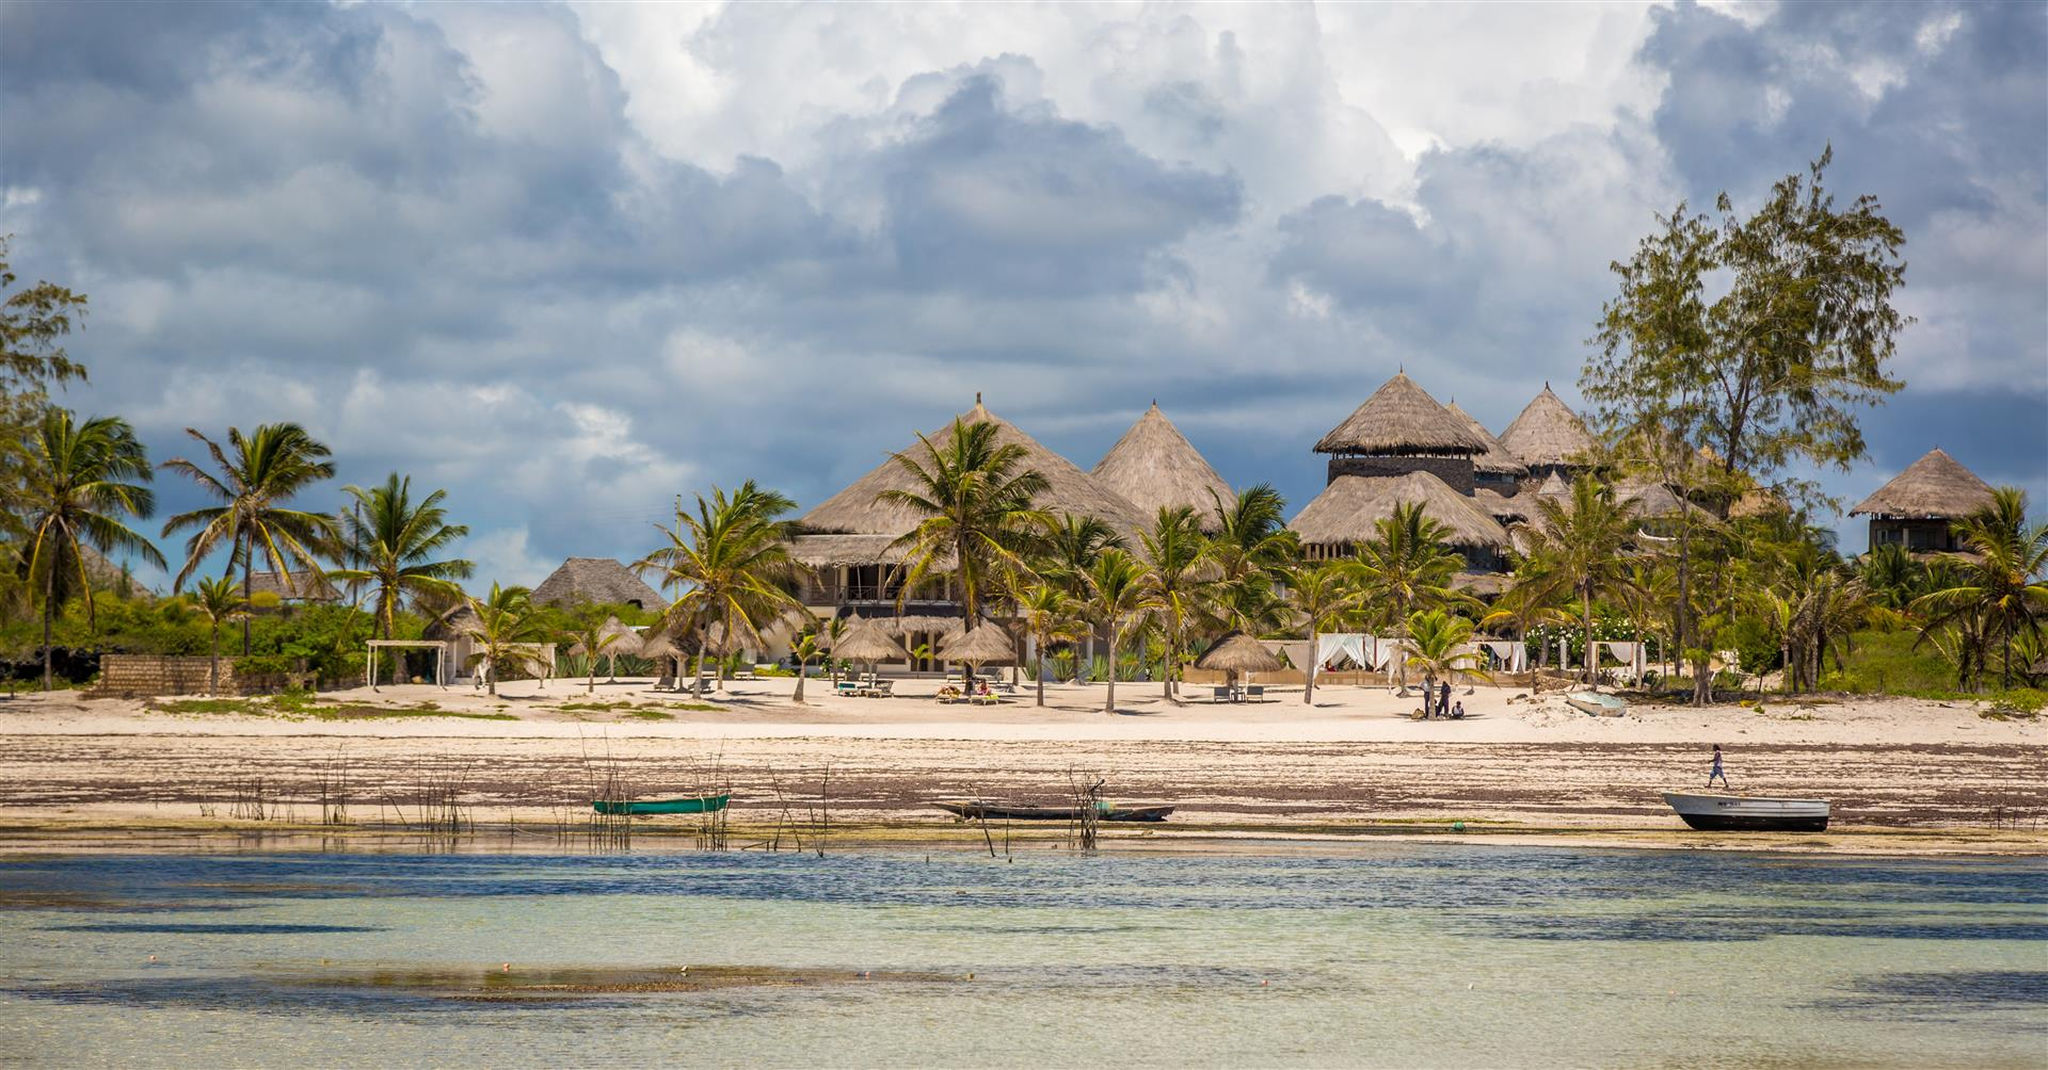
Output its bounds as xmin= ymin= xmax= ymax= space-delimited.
xmin=18 ymin=408 xmax=164 ymax=691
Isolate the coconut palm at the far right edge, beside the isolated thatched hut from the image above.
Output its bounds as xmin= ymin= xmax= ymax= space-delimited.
xmin=1913 ymin=486 xmax=2048 ymax=687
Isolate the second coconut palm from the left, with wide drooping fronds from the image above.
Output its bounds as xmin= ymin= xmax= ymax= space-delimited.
xmin=164 ymin=424 xmax=336 ymax=656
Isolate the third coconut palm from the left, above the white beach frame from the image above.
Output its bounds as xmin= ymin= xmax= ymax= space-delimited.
xmin=328 ymin=471 xmax=473 ymax=640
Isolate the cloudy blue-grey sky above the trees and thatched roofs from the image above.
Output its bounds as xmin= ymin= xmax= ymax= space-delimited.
xmin=0 ymin=2 xmax=2048 ymax=582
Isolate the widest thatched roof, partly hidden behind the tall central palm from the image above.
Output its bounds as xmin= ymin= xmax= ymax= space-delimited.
xmin=799 ymin=398 xmax=1149 ymax=535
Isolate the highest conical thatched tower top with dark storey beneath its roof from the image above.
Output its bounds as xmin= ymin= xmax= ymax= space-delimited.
xmin=1315 ymin=371 xmax=1487 ymax=494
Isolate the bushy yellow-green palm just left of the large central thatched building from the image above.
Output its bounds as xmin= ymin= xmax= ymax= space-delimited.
xmin=635 ymin=480 xmax=803 ymax=701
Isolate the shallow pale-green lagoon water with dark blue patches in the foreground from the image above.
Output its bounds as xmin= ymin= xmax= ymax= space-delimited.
xmin=0 ymin=845 xmax=2048 ymax=1066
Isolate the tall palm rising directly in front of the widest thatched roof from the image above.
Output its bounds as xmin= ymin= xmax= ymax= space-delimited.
xmin=874 ymin=418 xmax=1051 ymax=647
